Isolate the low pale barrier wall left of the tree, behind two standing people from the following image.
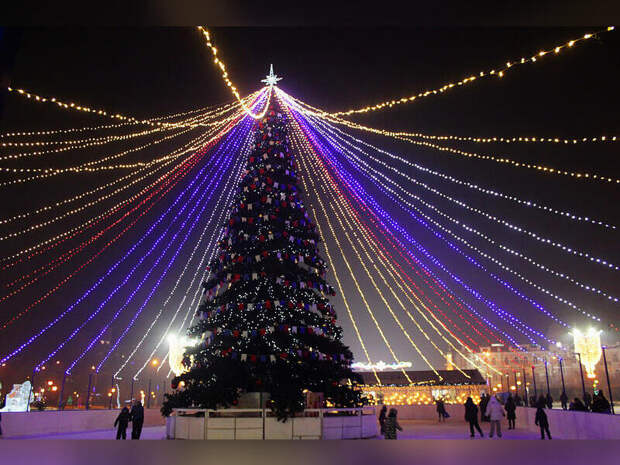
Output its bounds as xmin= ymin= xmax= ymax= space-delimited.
xmin=2 ymin=409 xmax=165 ymax=438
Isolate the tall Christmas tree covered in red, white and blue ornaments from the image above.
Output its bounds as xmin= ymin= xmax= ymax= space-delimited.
xmin=162 ymin=99 xmax=363 ymax=419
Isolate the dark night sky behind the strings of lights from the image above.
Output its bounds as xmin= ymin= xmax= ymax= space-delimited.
xmin=0 ymin=27 xmax=620 ymax=390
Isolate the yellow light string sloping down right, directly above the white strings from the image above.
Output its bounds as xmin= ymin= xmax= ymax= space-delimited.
xmin=284 ymin=89 xmax=620 ymax=183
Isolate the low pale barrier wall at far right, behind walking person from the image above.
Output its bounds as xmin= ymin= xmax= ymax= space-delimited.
xmin=516 ymin=407 xmax=620 ymax=439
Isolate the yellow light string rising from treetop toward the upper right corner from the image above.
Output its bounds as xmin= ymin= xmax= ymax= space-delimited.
xmin=326 ymin=26 xmax=615 ymax=116
